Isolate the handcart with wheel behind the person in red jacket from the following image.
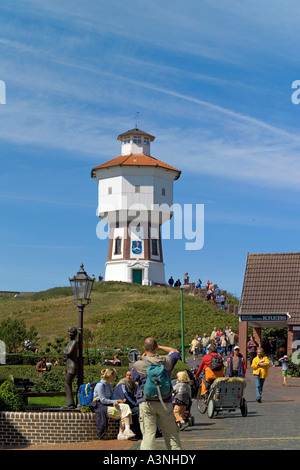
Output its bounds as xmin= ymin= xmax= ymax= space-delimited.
xmin=197 ymin=377 xmax=248 ymax=418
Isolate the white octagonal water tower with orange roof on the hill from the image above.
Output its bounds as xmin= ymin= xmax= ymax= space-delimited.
xmin=91 ymin=128 xmax=181 ymax=285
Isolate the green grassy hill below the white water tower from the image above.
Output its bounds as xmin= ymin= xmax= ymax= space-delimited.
xmin=0 ymin=282 xmax=238 ymax=349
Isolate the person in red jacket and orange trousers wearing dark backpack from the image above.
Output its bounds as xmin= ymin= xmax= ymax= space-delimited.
xmin=196 ymin=344 xmax=224 ymax=395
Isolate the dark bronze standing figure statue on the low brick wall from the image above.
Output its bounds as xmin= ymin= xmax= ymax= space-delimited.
xmin=63 ymin=326 xmax=78 ymax=409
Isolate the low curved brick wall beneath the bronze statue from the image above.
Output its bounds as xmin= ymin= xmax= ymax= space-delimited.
xmin=0 ymin=411 xmax=119 ymax=448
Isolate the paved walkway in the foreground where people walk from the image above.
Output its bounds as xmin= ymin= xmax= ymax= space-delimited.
xmin=2 ymin=360 xmax=300 ymax=451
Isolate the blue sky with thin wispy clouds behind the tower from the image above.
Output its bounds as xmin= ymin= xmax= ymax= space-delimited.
xmin=0 ymin=0 xmax=300 ymax=296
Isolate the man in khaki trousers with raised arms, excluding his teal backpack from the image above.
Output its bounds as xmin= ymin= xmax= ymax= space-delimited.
xmin=131 ymin=337 xmax=181 ymax=450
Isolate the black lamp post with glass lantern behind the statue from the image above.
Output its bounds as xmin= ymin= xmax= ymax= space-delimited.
xmin=69 ymin=264 xmax=94 ymax=389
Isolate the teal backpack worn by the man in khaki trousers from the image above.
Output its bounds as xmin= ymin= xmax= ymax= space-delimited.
xmin=142 ymin=359 xmax=172 ymax=409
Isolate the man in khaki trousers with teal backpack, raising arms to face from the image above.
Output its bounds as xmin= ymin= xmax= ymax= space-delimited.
xmin=131 ymin=337 xmax=181 ymax=450
